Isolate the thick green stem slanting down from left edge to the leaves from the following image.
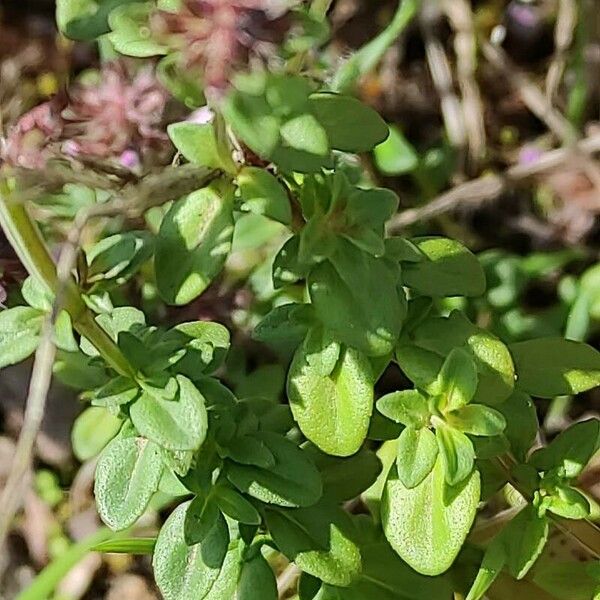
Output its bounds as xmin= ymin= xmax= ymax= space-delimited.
xmin=0 ymin=180 xmax=135 ymax=377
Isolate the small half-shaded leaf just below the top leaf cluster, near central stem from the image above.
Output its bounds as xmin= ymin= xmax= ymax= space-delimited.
xmin=237 ymin=167 xmax=292 ymax=225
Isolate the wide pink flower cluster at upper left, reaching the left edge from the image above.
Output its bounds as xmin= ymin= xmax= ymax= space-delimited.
xmin=2 ymin=62 xmax=171 ymax=169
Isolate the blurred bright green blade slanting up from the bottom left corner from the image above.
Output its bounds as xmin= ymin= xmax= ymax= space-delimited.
xmin=15 ymin=527 xmax=113 ymax=600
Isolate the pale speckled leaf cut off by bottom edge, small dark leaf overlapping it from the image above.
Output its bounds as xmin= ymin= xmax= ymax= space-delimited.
xmin=152 ymin=502 xmax=240 ymax=600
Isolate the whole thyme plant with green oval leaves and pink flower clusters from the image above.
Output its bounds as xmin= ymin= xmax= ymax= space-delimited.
xmin=0 ymin=0 xmax=600 ymax=600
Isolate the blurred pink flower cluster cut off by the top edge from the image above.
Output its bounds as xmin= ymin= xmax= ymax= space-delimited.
xmin=152 ymin=0 xmax=291 ymax=93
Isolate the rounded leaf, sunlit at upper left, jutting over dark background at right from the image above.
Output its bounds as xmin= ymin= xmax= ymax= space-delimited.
xmin=402 ymin=237 xmax=485 ymax=297
